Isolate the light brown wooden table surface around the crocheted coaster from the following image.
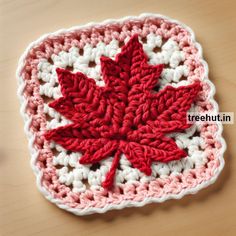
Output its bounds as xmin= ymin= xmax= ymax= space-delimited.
xmin=0 ymin=0 xmax=236 ymax=236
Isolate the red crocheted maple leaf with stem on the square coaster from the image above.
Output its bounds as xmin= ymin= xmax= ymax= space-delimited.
xmin=45 ymin=35 xmax=201 ymax=188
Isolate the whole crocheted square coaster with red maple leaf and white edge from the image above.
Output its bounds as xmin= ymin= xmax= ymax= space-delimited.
xmin=17 ymin=14 xmax=225 ymax=215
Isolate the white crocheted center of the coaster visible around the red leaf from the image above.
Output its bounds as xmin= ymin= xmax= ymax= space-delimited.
xmin=38 ymin=34 xmax=207 ymax=192
